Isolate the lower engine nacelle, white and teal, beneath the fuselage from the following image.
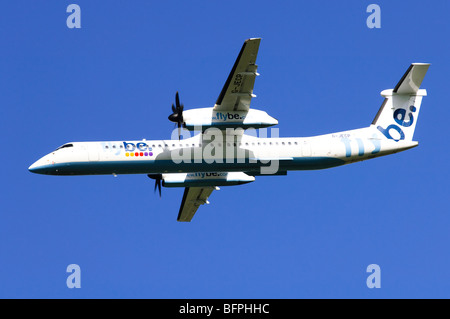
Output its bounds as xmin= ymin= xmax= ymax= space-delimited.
xmin=162 ymin=172 xmax=255 ymax=187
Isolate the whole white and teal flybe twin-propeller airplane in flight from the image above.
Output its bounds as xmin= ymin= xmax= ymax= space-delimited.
xmin=28 ymin=38 xmax=430 ymax=222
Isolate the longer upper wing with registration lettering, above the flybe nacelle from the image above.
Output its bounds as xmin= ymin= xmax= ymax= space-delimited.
xmin=214 ymin=38 xmax=261 ymax=111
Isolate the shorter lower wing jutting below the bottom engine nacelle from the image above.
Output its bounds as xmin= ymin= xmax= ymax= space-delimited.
xmin=177 ymin=186 xmax=215 ymax=222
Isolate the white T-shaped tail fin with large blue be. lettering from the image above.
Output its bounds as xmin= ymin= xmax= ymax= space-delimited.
xmin=372 ymin=63 xmax=430 ymax=141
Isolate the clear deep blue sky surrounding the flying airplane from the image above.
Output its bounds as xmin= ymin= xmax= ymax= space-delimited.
xmin=0 ymin=0 xmax=450 ymax=298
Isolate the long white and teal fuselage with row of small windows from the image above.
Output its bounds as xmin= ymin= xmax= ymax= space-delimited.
xmin=29 ymin=126 xmax=417 ymax=175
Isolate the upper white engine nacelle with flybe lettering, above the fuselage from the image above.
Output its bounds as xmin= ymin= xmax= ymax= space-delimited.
xmin=183 ymin=107 xmax=278 ymax=131
